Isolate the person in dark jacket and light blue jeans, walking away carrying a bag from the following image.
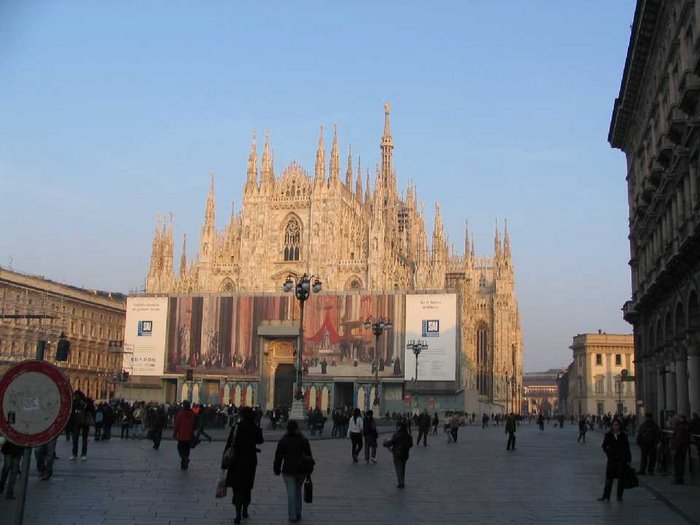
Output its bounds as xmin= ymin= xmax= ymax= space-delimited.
xmin=272 ymin=420 xmax=313 ymax=523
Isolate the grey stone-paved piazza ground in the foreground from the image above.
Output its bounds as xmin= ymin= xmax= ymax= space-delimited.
xmin=0 ymin=423 xmax=700 ymax=525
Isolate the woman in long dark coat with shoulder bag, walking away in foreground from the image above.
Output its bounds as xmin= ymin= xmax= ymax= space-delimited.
xmin=222 ymin=407 xmax=264 ymax=523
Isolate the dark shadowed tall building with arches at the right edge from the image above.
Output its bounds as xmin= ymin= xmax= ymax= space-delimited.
xmin=608 ymin=0 xmax=700 ymax=424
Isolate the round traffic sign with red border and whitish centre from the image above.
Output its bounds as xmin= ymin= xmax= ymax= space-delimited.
xmin=0 ymin=360 xmax=73 ymax=447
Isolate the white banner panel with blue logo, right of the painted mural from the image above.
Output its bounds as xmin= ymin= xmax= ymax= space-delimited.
xmin=404 ymin=294 xmax=457 ymax=381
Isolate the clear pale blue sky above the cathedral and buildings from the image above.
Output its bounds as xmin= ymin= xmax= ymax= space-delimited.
xmin=0 ymin=0 xmax=634 ymax=371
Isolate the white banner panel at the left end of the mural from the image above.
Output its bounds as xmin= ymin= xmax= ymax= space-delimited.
xmin=123 ymin=297 xmax=168 ymax=376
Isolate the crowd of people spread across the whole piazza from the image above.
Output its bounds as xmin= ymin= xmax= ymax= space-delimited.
xmin=0 ymin=390 xmax=700 ymax=523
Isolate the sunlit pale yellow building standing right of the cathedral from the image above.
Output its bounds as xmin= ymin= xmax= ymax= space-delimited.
xmin=566 ymin=330 xmax=636 ymax=417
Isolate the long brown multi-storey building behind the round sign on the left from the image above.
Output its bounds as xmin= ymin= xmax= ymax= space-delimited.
xmin=0 ymin=268 xmax=126 ymax=400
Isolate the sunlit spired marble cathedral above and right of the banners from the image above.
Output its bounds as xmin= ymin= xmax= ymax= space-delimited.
xmin=146 ymin=104 xmax=523 ymax=410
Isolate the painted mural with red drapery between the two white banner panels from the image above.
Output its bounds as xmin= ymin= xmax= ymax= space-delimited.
xmin=166 ymin=294 xmax=405 ymax=377
